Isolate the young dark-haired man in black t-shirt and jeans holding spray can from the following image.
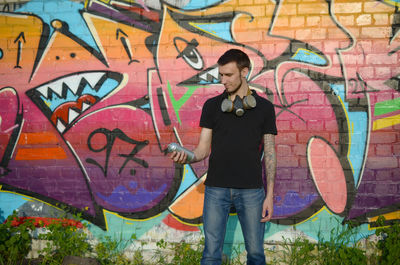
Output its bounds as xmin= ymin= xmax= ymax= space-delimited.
xmin=171 ymin=49 xmax=277 ymax=265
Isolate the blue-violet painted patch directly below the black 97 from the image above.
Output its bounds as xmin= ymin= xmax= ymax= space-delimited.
xmin=97 ymin=181 xmax=167 ymax=210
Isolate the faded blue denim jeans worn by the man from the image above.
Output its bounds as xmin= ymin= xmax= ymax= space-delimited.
xmin=201 ymin=186 xmax=266 ymax=265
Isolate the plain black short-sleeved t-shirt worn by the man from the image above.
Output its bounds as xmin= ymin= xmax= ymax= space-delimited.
xmin=200 ymin=91 xmax=277 ymax=189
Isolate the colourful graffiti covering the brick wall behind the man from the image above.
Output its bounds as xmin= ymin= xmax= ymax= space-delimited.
xmin=0 ymin=0 xmax=400 ymax=252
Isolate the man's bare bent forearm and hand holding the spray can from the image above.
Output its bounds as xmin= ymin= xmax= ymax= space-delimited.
xmin=171 ymin=127 xmax=212 ymax=164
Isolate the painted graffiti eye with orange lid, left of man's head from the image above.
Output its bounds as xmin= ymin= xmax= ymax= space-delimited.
xmin=174 ymin=37 xmax=204 ymax=70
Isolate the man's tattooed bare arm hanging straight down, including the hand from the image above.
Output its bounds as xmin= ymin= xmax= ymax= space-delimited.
xmin=261 ymin=134 xmax=276 ymax=222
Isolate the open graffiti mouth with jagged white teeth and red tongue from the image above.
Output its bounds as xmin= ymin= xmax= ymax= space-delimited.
xmin=27 ymin=71 xmax=122 ymax=133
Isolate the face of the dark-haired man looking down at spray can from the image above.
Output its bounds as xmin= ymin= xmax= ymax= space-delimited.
xmin=218 ymin=62 xmax=246 ymax=93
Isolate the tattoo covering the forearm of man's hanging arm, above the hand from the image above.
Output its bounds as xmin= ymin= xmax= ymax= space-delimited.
xmin=264 ymin=134 xmax=276 ymax=186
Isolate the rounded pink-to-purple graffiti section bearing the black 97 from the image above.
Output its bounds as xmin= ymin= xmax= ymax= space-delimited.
xmin=65 ymin=105 xmax=174 ymax=213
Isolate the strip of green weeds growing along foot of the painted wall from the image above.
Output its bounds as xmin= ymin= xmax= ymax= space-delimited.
xmin=0 ymin=212 xmax=400 ymax=265
